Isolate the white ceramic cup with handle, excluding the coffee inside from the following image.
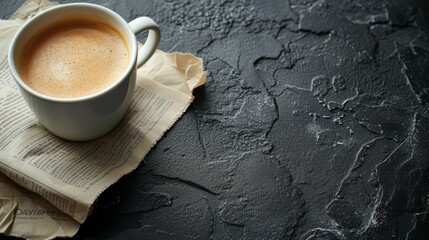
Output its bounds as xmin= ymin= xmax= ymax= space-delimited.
xmin=8 ymin=3 xmax=160 ymax=141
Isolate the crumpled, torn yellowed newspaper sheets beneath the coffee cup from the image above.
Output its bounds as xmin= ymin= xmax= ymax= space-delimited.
xmin=0 ymin=0 xmax=206 ymax=239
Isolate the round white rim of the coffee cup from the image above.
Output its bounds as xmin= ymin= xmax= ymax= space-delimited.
xmin=8 ymin=3 xmax=137 ymax=103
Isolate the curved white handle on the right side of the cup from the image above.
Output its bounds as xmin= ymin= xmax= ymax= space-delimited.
xmin=128 ymin=17 xmax=161 ymax=68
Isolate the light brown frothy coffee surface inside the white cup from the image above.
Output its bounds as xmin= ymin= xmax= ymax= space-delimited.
xmin=20 ymin=18 xmax=130 ymax=98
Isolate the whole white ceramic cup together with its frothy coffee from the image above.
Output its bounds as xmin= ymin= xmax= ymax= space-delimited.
xmin=8 ymin=3 xmax=161 ymax=141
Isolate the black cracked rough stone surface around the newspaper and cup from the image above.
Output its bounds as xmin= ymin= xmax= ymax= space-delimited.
xmin=0 ymin=0 xmax=429 ymax=240
